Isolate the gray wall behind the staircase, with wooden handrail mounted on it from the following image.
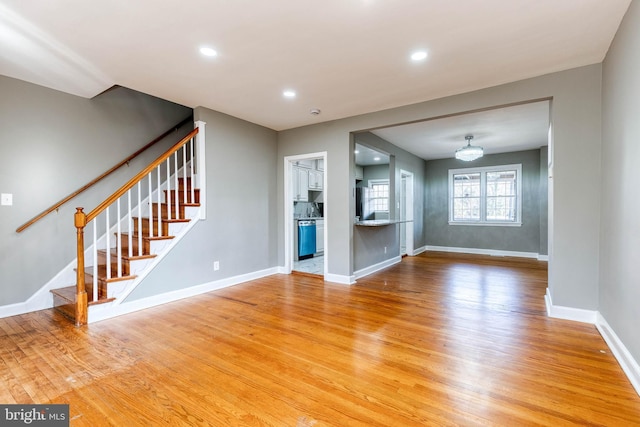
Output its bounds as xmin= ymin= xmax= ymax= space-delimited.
xmin=0 ymin=76 xmax=192 ymax=306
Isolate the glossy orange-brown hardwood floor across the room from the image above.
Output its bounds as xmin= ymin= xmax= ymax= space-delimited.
xmin=0 ymin=253 xmax=640 ymax=427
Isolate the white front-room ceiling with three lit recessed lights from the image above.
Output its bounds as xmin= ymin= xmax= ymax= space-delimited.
xmin=0 ymin=0 xmax=631 ymax=137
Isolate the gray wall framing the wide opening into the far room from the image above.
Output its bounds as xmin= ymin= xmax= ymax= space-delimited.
xmin=277 ymin=64 xmax=602 ymax=310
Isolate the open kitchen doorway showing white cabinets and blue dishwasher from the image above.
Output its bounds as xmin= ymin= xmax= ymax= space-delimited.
xmin=284 ymin=152 xmax=328 ymax=276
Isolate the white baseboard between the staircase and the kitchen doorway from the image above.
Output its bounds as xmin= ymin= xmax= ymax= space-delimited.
xmin=88 ymin=267 xmax=278 ymax=323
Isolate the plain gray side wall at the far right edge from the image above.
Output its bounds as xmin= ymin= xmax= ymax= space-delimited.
xmin=600 ymin=1 xmax=640 ymax=368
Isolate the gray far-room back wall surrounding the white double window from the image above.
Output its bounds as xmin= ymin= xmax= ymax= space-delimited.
xmin=425 ymin=150 xmax=546 ymax=254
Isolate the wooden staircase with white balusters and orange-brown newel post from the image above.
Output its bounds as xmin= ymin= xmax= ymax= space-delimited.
xmin=50 ymin=122 xmax=204 ymax=326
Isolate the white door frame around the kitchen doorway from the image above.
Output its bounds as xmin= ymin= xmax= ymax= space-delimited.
xmin=283 ymin=151 xmax=329 ymax=277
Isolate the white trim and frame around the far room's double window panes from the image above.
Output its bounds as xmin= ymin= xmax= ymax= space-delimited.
xmin=449 ymin=163 xmax=522 ymax=227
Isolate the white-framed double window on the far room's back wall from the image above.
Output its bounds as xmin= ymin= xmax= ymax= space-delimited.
xmin=449 ymin=164 xmax=522 ymax=225
